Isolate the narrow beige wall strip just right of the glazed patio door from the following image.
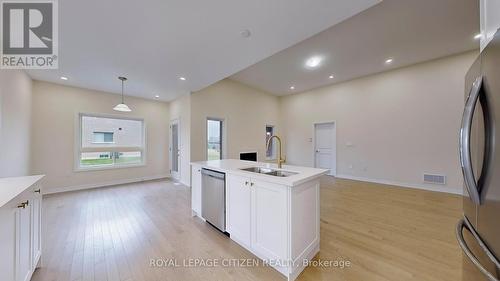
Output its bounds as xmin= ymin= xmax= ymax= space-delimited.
xmin=170 ymin=95 xmax=191 ymax=185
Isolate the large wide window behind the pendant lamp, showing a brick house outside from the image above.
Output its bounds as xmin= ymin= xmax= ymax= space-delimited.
xmin=77 ymin=114 xmax=144 ymax=170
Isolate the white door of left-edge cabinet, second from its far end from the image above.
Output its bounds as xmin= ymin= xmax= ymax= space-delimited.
xmin=15 ymin=201 xmax=31 ymax=281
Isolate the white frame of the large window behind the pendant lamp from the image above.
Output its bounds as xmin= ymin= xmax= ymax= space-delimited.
xmin=73 ymin=112 xmax=147 ymax=172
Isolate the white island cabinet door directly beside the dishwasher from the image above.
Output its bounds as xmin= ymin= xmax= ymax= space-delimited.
xmin=226 ymin=175 xmax=251 ymax=248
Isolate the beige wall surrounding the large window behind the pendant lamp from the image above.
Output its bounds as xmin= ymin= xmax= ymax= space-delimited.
xmin=31 ymin=81 xmax=170 ymax=193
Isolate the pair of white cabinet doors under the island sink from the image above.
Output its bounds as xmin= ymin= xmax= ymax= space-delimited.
xmin=227 ymin=174 xmax=288 ymax=262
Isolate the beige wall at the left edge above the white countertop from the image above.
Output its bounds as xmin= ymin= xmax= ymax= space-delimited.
xmin=0 ymin=70 xmax=32 ymax=178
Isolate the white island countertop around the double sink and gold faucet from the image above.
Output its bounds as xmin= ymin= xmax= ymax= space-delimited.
xmin=191 ymin=159 xmax=328 ymax=186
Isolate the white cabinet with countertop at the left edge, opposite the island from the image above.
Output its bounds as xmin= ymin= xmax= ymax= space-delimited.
xmin=0 ymin=176 xmax=43 ymax=281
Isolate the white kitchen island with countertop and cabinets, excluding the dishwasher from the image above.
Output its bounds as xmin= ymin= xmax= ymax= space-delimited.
xmin=191 ymin=159 xmax=328 ymax=280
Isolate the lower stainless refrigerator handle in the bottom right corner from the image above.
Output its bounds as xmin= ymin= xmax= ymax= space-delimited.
xmin=456 ymin=216 xmax=500 ymax=281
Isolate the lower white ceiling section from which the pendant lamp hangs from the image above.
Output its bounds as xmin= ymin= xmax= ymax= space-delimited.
xmin=28 ymin=0 xmax=379 ymax=101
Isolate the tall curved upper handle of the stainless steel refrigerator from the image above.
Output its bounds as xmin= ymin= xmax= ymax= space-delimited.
xmin=459 ymin=76 xmax=483 ymax=205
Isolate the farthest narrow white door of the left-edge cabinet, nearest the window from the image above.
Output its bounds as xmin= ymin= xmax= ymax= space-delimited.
xmin=31 ymin=195 xmax=42 ymax=271
